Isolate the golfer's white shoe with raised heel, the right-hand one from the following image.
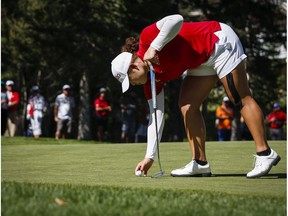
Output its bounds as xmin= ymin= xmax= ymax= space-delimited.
xmin=247 ymin=149 xmax=281 ymax=178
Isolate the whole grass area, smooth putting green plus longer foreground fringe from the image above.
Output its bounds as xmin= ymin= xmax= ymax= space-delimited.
xmin=1 ymin=137 xmax=287 ymax=215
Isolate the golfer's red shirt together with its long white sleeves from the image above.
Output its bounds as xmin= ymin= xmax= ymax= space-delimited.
xmin=136 ymin=15 xmax=221 ymax=159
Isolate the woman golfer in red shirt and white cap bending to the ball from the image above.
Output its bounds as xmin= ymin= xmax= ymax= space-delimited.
xmin=111 ymin=15 xmax=281 ymax=178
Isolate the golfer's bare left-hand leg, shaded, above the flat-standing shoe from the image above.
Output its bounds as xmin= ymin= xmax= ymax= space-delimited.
xmin=179 ymin=76 xmax=218 ymax=161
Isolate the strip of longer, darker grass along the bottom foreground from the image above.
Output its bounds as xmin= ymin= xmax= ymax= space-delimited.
xmin=2 ymin=182 xmax=286 ymax=216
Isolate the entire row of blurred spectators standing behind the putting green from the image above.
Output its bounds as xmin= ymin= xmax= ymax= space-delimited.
xmin=1 ymin=80 xmax=287 ymax=143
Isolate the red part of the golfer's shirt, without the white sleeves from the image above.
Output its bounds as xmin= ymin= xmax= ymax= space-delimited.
xmin=136 ymin=21 xmax=221 ymax=99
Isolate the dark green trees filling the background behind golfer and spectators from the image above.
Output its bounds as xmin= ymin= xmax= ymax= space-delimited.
xmin=1 ymin=0 xmax=287 ymax=140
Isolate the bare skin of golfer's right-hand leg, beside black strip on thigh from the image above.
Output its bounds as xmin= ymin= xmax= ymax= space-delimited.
xmin=221 ymin=61 xmax=268 ymax=152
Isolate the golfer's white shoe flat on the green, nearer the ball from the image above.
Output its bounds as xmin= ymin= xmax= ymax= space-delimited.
xmin=171 ymin=160 xmax=211 ymax=177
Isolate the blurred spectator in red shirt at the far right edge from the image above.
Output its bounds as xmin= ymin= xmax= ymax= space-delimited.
xmin=266 ymin=103 xmax=287 ymax=140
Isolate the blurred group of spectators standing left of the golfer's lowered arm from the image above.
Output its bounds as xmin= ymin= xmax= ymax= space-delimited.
xmin=1 ymin=80 xmax=148 ymax=143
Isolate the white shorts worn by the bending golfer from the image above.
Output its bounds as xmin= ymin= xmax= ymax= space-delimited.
xmin=187 ymin=23 xmax=247 ymax=79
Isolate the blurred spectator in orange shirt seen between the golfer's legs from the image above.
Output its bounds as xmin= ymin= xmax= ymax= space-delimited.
xmin=216 ymin=97 xmax=233 ymax=141
